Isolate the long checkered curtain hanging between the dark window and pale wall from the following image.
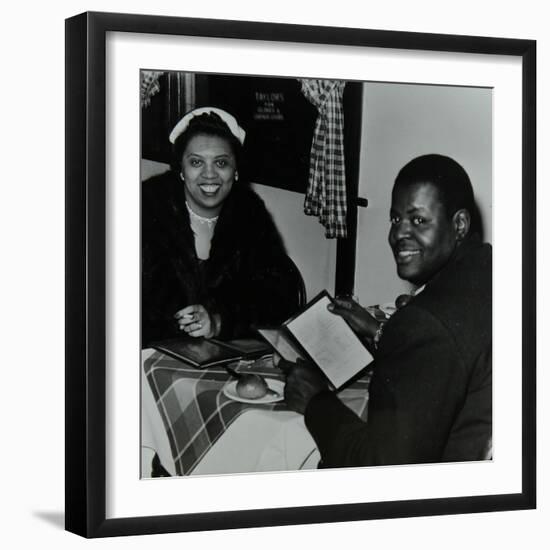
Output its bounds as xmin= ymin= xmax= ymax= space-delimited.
xmin=300 ymin=79 xmax=347 ymax=239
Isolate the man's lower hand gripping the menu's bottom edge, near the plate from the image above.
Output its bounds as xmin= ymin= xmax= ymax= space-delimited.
xmin=279 ymin=359 xmax=328 ymax=414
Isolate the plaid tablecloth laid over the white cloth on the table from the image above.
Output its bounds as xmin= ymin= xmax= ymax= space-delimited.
xmin=143 ymin=351 xmax=369 ymax=475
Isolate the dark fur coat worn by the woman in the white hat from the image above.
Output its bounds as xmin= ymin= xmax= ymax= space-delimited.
xmin=141 ymin=171 xmax=303 ymax=347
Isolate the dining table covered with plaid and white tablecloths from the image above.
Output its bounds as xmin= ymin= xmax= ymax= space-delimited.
xmin=141 ymin=348 xmax=371 ymax=478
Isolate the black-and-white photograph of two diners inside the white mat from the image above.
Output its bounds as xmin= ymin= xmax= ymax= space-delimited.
xmin=140 ymin=68 xmax=498 ymax=479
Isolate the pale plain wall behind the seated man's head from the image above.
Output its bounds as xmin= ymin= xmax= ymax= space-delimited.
xmin=355 ymin=82 xmax=492 ymax=305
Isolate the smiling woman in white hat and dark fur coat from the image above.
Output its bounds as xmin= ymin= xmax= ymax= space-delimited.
xmin=142 ymin=107 xmax=299 ymax=347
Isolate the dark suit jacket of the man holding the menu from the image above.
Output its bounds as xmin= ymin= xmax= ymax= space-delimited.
xmin=305 ymin=237 xmax=492 ymax=467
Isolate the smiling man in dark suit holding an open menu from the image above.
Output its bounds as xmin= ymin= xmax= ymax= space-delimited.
xmin=283 ymin=155 xmax=492 ymax=467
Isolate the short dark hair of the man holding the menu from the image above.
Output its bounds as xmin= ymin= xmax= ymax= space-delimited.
xmin=395 ymin=154 xmax=481 ymax=233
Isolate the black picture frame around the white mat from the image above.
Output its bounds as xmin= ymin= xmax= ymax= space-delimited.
xmin=65 ymin=13 xmax=536 ymax=537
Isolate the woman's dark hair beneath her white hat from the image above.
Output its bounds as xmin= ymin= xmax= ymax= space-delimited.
xmin=171 ymin=113 xmax=242 ymax=173
